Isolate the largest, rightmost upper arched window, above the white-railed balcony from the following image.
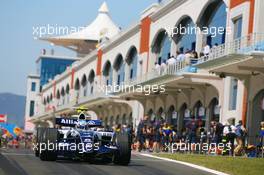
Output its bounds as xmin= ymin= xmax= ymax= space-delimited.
xmin=198 ymin=0 xmax=227 ymax=47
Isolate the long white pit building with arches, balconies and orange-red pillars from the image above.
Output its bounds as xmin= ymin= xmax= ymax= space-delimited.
xmin=25 ymin=0 xmax=264 ymax=142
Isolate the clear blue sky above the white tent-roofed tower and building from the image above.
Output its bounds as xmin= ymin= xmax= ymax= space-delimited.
xmin=0 ymin=0 xmax=157 ymax=95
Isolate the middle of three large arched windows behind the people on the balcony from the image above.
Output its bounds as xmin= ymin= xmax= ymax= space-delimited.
xmin=173 ymin=16 xmax=196 ymax=53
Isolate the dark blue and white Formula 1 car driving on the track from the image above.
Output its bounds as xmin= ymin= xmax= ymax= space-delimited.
xmin=35 ymin=113 xmax=131 ymax=165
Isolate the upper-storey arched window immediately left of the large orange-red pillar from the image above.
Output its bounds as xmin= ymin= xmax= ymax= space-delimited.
xmin=126 ymin=47 xmax=138 ymax=80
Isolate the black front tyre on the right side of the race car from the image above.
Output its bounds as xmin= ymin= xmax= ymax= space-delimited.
xmin=113 ymin=133 xmax=131 ymax=165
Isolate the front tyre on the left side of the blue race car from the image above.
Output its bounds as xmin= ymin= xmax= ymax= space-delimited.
xmin=39 ymin=128 xmax=58 ymax=161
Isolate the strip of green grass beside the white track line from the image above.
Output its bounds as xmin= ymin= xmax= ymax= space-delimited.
xmin=155 ymin=154 xmax=264 ymax=175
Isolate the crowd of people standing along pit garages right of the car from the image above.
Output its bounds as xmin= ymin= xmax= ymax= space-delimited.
xmin=113 ymin=116 xmax=264 ymax=156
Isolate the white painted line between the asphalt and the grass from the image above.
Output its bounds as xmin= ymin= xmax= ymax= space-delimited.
xmin=137 ymin=153 xmax=229 ymax=175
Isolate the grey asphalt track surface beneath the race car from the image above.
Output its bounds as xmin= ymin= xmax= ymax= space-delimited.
xmin=0 ymin=149 xmax=214 ymax=175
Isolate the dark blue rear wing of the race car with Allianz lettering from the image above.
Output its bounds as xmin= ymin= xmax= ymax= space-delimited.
xmin=55 ymin=118 xmax=102 ymax=127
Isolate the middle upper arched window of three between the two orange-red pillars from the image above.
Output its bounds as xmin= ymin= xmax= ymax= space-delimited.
xmin=114 ymin=54 xmax=125 ymax=85
